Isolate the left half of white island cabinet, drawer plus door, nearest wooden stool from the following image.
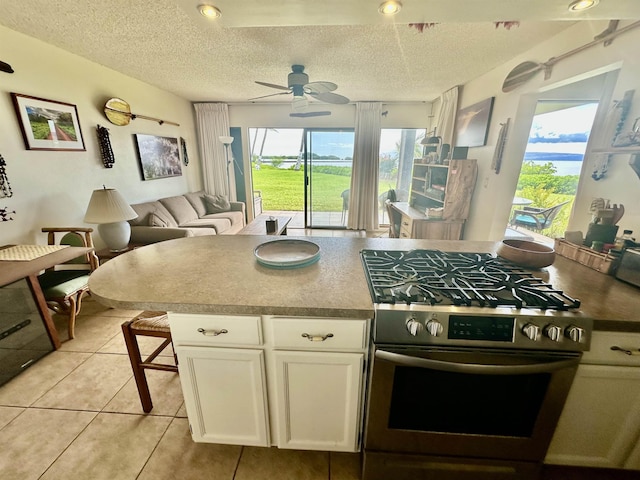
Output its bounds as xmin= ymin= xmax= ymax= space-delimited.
xmin=169 ymin=314 xmax=270 ymax=447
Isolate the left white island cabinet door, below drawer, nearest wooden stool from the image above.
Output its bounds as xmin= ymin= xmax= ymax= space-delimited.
xmin=176 ymin=347 xmax=269 ymax=447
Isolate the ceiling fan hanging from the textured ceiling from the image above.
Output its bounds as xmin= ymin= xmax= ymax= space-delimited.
xmin=249 ymin=65 xmax=349 ymax=117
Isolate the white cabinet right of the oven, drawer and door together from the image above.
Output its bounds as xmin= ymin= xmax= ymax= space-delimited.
xmin=545 ymin=332 xmax=640 ymax=470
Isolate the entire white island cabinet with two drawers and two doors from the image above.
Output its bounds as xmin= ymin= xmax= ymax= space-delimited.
xmin=169 ymin=313 xmax=369 ymax=452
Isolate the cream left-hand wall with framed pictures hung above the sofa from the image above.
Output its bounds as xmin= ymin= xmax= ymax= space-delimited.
xmin=0 ymin=26 xmax=202 ymax=246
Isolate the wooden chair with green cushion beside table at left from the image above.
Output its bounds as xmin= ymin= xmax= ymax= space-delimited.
xmin=38 ymin=227 xmax=98 ymax=339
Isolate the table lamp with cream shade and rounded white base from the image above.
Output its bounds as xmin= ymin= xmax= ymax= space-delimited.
xmin=84 ymin=186 xmax=138 ymax=252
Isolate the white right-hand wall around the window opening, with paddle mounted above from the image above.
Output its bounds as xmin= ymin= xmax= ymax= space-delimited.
xmin=460 ymin=22 xmax=640 ymax=240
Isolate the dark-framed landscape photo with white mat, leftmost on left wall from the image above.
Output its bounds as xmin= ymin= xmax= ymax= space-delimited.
xmin=11 ymin=93 xmax=85 ymax=151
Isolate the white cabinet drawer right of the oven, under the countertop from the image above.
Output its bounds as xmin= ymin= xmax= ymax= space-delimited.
xmin=582 ymin=332 xmax=640 ymax=367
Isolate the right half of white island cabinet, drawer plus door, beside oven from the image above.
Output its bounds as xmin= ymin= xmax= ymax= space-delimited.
xmin=264 ymin=317 xmax=368 ymax=452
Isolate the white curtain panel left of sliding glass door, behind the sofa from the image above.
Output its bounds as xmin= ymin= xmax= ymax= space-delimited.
xmin=198 ymin=103 xmax=235 ymax=200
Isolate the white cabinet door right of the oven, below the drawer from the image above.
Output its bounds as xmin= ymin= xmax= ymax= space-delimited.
xmin=545 ymin=365 xmax=640 ymax=468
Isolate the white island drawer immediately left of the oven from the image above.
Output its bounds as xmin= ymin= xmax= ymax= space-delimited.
xmin=269 ymin=317 xmax=367 ymax=351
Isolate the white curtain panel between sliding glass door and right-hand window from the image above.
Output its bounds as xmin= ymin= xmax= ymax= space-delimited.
xmin=347 ymin=102 xmax=382 ymax=230
